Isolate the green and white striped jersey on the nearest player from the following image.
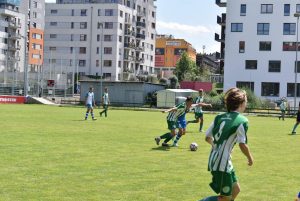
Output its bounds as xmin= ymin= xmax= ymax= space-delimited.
xmin=206 ymin=112 xmax=248 ymax=172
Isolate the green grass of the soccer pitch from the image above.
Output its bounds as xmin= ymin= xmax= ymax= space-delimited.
xmin=0 ymin=105 xmax=300 ymax=201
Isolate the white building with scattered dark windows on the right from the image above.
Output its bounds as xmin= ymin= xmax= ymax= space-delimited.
xmin=216 ymin=0 xmax=300 ymax=100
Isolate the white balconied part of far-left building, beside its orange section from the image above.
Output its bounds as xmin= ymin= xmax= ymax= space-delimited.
xmin=0 ymin=0 xmax=26 ymax=84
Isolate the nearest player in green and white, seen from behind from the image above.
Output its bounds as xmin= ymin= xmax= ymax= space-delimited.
xmin=200 ymin=88 xmax=253 ymax=201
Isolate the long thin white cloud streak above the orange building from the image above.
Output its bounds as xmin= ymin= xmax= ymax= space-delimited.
xmin=157 ymin=21 xmax=211 ymax=35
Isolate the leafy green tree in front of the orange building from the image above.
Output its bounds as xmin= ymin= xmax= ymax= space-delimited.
xmin=174 ymin=52 xmax=196 ymax=82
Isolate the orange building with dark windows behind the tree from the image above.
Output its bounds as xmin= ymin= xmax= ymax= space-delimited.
xmin=155 ymin=35 xmax=197 ymax=77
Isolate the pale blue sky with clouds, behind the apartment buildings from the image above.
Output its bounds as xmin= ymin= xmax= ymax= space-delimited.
xmin=46 ymin=0 xmax=224 ymax=53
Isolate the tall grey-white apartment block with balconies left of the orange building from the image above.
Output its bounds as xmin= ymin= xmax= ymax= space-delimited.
xmin=44 ymin=0 xmax=156 ymax=81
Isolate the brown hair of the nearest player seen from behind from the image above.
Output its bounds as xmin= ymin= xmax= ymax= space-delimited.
xmin=224 ymin=88 xmax=247 ymax=112
